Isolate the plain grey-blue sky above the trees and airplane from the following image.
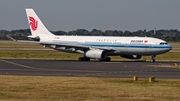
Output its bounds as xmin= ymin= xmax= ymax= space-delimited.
xmin=0 ymin=0 xmax=180 ymax=32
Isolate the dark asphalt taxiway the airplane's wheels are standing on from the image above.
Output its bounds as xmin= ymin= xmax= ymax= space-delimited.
xmin=0 ymin=59 xmax=180 ymax=78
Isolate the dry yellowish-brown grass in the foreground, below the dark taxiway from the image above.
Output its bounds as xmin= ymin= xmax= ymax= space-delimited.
xmin=0 ymin=76 xmax=180 ymax=101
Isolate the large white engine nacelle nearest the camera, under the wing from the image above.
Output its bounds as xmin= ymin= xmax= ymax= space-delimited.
xmin=84 ymin=50 xmax=107 ymax=59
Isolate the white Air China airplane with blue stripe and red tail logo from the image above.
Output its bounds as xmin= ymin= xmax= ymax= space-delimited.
xmin=9 ymin=8 xmax=172 ymax=62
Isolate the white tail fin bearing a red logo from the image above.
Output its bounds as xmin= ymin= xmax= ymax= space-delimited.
xmin=26 ymin=8 xmax=54 ymax=39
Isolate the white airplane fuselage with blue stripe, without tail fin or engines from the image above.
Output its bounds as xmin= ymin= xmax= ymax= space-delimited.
xmin=42 ymin=36 xmax=172 ymax=55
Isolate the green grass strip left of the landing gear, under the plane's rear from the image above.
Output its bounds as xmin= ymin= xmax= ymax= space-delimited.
xmin=0 ymin=50 xmax=82 ymax=60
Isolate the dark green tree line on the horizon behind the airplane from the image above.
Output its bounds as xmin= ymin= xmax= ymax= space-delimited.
xmin=0 ymin=29 xmax=180 ymax=42
